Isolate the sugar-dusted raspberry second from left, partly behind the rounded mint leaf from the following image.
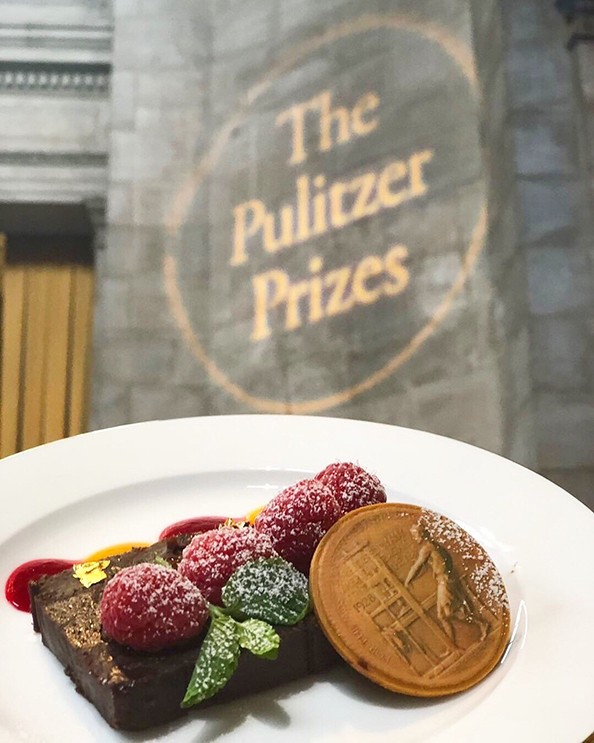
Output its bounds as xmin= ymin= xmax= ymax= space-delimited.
xmin=178 ymin=526 xmax=278 ymax=604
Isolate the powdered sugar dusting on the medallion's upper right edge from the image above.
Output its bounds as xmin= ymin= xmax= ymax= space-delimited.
xmin=417 ymin=509 xmax=509 ymax=613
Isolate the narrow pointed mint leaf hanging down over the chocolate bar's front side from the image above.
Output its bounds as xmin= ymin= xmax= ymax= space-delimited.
xmin=181 ymin=612 xmax=240 ymax=708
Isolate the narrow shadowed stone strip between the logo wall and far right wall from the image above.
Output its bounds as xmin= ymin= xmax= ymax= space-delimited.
xmin=472 ymin=0 xmax=537 ymax=467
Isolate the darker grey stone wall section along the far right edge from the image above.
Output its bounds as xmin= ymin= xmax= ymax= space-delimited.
xmin=502 ymin=0 xmax=594 ymax=506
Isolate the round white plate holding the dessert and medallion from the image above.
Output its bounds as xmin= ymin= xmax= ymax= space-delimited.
xmin=0 ymin=416 xmax=594 ymax=743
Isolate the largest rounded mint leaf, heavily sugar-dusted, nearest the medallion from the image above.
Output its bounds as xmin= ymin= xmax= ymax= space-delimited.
xmin=222 ymin=557 xmax=310 ymax=625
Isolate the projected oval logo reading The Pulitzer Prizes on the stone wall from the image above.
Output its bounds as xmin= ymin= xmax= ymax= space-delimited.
xmin=164 ymin=15 xmax=480 ymax=413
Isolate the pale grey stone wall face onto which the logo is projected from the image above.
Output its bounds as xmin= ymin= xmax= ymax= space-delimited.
xmin=93 ymin=0 xmax=534 ymax=464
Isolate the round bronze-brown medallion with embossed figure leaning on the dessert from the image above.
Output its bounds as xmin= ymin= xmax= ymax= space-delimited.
xmin=310 ymin=503 xmax=510 ymax=697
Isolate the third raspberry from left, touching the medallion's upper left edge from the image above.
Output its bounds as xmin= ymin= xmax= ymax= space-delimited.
xmin=254 ymin=480 xmax=341 ymax=574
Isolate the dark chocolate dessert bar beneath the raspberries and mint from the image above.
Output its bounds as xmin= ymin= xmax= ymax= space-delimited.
xmin=30 ymin=537 xmax=339 ymax=730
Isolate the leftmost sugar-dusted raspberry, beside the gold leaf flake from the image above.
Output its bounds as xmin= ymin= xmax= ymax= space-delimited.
xmin=100 ymin=562 xmax=208 ymax=651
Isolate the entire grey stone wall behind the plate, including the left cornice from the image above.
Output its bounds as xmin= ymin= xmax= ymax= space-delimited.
xmin=0 ymin=0 xmax=594 ymax=505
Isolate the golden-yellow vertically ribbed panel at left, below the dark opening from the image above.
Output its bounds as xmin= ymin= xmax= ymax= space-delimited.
xmin=0 ymin=236 xmax=94 ymax=457
